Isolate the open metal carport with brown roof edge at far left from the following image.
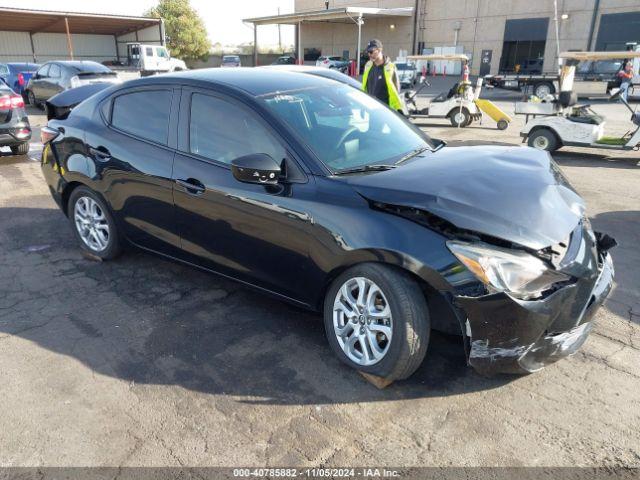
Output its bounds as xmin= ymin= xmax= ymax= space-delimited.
xmin=0 ymin=7 xmax=165 ymax=62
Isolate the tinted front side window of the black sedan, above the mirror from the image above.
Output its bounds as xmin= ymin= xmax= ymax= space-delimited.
xmin=189 ymin=93 xmax=286 ymax=164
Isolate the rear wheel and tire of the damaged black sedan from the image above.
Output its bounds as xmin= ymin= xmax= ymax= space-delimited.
xmin=67 ymin=186 xmax=122 ymax=260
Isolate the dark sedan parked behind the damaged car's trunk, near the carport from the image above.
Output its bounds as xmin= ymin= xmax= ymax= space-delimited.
xmin=26 ymin=60 xmax=120 ymax=106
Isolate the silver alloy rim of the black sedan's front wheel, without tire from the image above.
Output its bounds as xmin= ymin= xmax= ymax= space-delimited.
xmin=333 ymin=277 xmax=393 ymax=366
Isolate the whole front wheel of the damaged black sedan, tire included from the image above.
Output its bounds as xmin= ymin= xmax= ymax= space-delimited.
xmin=324 ymin=263 xmax=431 ymax=381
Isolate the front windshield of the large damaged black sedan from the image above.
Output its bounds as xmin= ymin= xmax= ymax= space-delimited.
xmin=264 ymin=85 xmax=433 ymax=172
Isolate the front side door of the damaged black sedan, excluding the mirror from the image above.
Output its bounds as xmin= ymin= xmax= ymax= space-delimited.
xmin=173 ymin=88 xmax=315 ymax=299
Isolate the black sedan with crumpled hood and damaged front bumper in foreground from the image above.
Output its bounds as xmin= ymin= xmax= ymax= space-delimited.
xmin=42 ymin=69 xmax=615 ymax=380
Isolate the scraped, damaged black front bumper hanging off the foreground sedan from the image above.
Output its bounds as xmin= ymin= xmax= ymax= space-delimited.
xmin=455 ymin=251 xmax=614 ymax=374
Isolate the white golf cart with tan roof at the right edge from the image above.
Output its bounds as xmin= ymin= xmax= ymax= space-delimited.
xmin=515 ymin=51 xmax=640 ymax=152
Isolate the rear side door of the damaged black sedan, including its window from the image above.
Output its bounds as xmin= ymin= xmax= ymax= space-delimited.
xmin=85 ymin=85 xmax=180 ymax=256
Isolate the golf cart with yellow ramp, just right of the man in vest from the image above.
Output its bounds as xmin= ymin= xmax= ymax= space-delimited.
xmin=404 ymin=53 xmax=511 ymax=130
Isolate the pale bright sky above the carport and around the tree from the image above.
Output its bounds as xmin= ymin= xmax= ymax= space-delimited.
xmin=0 ymin=0 xmax=295 ymax=45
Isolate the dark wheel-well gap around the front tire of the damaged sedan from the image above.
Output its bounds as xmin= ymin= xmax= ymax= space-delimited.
xmin=317 ymin=262 xmax=462 ymax=335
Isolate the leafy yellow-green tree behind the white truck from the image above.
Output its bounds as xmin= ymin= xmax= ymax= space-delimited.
xmin=145 ymin=0 xmax=211 ymax=60
